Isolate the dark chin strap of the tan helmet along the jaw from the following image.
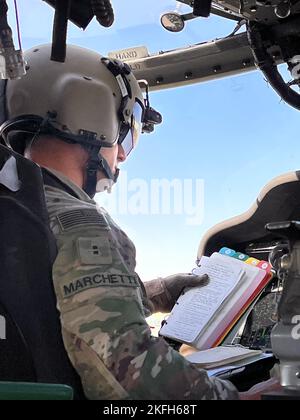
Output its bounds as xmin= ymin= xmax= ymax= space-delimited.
xmin=83 ymin=147 xmax=120 ymax=198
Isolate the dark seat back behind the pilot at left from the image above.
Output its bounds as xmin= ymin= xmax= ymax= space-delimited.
xmin=0 ymin=145 xmax=84 ymax=398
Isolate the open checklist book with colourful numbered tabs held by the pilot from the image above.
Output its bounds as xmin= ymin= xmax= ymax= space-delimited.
xmin=159 ymin=248 xmax=272 ymax=350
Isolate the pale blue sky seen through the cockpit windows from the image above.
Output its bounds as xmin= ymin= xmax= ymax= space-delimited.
xmin=8 ymin=0 xmax=300 ymax=280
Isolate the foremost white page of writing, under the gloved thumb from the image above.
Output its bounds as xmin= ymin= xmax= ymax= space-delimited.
xmin=160 ymin=257 xmax=244 ymax=344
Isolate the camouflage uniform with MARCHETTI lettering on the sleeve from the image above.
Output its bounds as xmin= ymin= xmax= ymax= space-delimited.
xmin=45 ymin=171 xmax=237 ymax=400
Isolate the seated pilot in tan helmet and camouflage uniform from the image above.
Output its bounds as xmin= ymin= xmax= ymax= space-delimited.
xmin=1 ymin=45 xmax=276 ymax=400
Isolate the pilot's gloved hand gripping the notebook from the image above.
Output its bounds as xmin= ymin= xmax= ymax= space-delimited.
xmin=144 ymin=274 xmax=209 ymax=312
